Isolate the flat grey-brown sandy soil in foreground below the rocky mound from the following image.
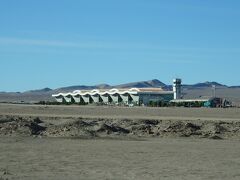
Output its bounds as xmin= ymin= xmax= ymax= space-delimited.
xmin=0 ymin=137 xmax=240 ymax=180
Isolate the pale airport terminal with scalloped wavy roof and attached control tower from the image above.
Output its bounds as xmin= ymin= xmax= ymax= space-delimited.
xmin=52 ymin=79 xmax=181 ymax=105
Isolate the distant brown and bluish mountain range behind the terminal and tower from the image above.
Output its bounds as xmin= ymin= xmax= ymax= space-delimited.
xmin=0 ymin=79 xmax=240 ymax=103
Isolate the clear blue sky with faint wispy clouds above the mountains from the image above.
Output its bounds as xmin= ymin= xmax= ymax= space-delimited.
xmin=0 ymin=0 xmax=240 ymax=91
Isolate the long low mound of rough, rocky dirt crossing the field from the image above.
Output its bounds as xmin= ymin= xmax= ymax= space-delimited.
xmin=0 ymin=117 xmax=240 ymax=139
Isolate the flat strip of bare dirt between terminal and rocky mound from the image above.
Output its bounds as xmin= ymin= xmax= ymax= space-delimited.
xmin=0 ymin=104 xmax=240 ymax=120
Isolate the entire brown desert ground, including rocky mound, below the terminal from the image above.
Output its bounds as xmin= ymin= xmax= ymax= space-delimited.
xmin=0 ymin=104 xmax=240 ymax=180
